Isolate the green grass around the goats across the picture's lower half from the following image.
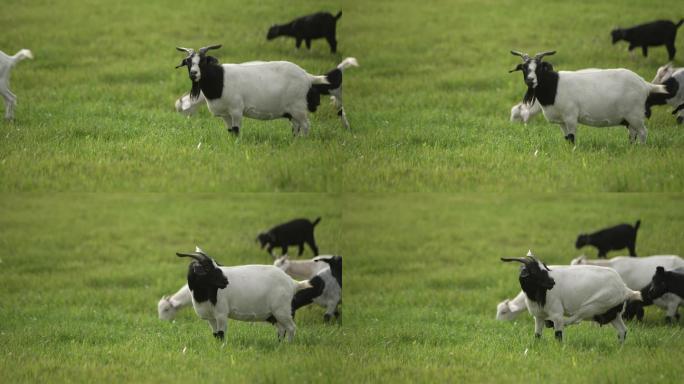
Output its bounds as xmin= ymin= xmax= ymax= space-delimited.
xmin=0 ymin=194 xmax=684 ymax=383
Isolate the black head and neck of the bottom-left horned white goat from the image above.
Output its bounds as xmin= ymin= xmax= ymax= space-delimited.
xmin=176 ymin=252 xmax=228 ymax=305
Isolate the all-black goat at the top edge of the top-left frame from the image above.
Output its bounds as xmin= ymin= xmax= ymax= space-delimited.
xmin=266 ymin=11 xmax=342 ymax=53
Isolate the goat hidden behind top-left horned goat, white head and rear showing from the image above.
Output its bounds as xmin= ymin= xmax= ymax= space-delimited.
xmin=175 ymin=57 xmax=359 ymax=129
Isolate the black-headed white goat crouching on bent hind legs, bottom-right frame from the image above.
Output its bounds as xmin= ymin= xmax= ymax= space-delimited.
xmin=501 ymin=252 xmax=641 ymax=343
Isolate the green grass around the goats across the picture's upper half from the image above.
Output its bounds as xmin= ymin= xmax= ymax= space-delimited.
xmin=0 ymin=0 xmax=684 ymax=192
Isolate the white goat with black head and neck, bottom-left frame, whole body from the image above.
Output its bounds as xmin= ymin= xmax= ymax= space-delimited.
xmin=176 ymin=251 xmax=311 ymax=341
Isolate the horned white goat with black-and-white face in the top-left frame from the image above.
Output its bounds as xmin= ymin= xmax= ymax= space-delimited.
xmin=176 ymin=45 xmax=330 ymax=136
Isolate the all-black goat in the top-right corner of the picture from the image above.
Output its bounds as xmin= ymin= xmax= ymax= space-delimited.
xmin=610 ymin=19 xmax=684 ymax=60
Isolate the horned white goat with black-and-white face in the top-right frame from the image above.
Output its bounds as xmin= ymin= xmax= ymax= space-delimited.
xmin=510 ymin=51 xmax=669 ymax=145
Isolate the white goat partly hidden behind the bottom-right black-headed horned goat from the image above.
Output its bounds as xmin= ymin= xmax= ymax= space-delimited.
xmin=570 ymin=255 xmax=684 ymax=322
